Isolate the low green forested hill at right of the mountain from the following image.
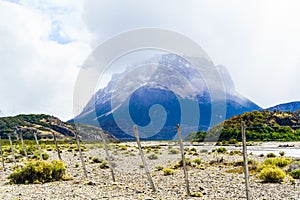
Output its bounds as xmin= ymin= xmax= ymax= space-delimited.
xmin=191 ymin=111 xmax=300 ymax=141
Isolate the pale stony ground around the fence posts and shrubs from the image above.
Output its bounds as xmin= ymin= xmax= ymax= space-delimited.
xmin=0 ymin=142 xmax=300 ymax=200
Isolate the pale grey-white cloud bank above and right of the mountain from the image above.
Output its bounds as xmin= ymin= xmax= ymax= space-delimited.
xmin=84 ymin=0 xmax=300 ymax=107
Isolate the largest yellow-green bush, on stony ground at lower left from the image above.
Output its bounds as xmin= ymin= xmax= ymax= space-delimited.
xmin=8 ymin=160 xmax=66 ymax=184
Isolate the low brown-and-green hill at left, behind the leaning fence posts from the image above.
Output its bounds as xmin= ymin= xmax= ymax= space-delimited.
xmin=0 ymin=114 xmax=117 ymax=141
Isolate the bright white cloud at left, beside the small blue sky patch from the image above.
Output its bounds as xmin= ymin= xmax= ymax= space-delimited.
xmin=0 ymin=2 xmax=90 ymax=119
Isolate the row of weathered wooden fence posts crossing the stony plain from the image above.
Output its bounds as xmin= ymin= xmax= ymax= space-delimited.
xmin=0 ymin=123 xmax=300 ymax=200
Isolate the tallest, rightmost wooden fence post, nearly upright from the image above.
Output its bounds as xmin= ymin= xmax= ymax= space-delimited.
xmin=242 ymin=122 xmax=250 ymax=200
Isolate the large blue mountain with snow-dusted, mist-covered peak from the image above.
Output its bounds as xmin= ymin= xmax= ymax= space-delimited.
xmin=75 ymin=54 xmax=261 ymax=139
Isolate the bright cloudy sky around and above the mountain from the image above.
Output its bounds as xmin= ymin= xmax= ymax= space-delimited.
xmin=0 ymin=0 xmax=300 ymax=120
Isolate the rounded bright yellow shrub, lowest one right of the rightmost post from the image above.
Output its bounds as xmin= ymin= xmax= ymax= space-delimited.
xmin=258 ymin=166 xmax=286 ymax=182
